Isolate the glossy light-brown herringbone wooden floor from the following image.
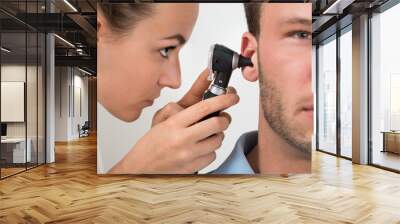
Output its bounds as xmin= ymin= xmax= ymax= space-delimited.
xmin=0 ymin=134 xmax=400 ymax=224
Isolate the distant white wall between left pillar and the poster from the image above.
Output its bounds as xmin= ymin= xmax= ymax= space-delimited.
xmin=55 ymin=67 xmax=88 ymax=141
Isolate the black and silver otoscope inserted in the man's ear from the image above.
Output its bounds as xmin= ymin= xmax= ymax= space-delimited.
xmin=203 ymin=44 xmax=253 ymax=120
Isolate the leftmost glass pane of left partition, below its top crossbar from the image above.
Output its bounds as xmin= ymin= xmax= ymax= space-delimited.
xmin=0 ymin=29 xmax=30 ymax=178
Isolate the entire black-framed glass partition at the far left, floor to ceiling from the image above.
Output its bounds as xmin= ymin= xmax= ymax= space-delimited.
xmin=0 ymin=0 xmax=45 ymax=177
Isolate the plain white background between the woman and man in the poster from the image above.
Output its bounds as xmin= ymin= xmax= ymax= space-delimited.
xmin=97 ymin=3 xmax=259 ymax=173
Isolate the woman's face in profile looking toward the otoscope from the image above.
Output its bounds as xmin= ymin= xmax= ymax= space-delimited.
xmin=97 ymin=4 xmax=198 ymax=122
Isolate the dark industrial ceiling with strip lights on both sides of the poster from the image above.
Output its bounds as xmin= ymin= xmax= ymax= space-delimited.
xmin=0 ymin=0 xmax=396 ymax=72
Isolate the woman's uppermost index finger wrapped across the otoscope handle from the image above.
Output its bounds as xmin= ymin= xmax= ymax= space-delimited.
xmin=171 ymin=94 xmax=239 ymax=127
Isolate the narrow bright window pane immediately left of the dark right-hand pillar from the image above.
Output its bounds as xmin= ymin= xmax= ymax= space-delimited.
xmin=340 ymin=30 xmax=353 ymax=158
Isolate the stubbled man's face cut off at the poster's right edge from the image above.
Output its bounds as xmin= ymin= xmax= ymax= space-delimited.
xmin=257 ymin=3 xmax=314 ymax=153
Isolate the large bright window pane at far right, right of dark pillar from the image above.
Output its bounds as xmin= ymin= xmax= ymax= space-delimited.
xmin=371 ymin=4 xmax=400 ymax=170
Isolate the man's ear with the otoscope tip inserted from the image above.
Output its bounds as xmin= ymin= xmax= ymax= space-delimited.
xmin=240 ymin=32 xmax=258 ymax=82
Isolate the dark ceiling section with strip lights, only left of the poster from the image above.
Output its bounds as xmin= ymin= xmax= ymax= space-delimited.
xmin=0 ymin=0 xmax=97 ymax=74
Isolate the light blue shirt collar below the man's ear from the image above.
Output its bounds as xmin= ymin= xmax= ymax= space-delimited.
xmin=212 ymin=131 xmax=258 ymax=174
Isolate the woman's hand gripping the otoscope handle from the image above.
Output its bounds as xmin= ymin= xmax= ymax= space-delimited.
xmin=110 ymin=69 xmax=239 ymax=174
